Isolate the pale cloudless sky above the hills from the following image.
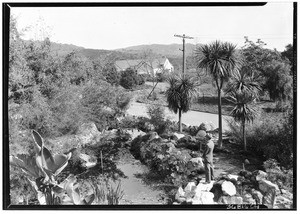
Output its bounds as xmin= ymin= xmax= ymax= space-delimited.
xmin=11 ymin=2 xmax=293 ymax=51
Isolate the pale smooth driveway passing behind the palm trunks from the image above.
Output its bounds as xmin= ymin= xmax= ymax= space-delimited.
xmin=127 ymin=102 xmax=232 ymax=131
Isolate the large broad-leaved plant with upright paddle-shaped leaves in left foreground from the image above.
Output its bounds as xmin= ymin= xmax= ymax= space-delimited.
xmin=10 ymin=130 xmax=94 ymax=205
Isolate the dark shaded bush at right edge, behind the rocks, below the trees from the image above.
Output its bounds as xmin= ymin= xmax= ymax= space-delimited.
xmin=229 ymin=112 xmax=293 ymax=169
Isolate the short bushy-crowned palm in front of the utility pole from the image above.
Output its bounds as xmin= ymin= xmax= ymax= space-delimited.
xmin=166 ymin=75 xmax=196 ymax=132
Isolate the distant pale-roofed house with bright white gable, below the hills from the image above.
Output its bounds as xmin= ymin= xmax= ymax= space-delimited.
xmin=115 ymin=57 xmax=174 ymax=75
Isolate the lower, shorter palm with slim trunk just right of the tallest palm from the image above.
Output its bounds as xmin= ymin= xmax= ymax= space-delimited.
xmin=228 ymin=90 xmax=257 ymax=151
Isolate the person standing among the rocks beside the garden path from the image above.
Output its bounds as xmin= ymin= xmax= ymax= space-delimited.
xmin=202 ymin=133 xmax=215 ymax=183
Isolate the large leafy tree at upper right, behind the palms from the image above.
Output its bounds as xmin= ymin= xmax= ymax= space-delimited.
xmin=242 ymin=37 xmax=293 ymax=101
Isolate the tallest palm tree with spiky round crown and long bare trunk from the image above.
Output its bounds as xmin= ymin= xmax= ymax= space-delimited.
xmin=195 ymin=41 xmax=240 ymax=148
